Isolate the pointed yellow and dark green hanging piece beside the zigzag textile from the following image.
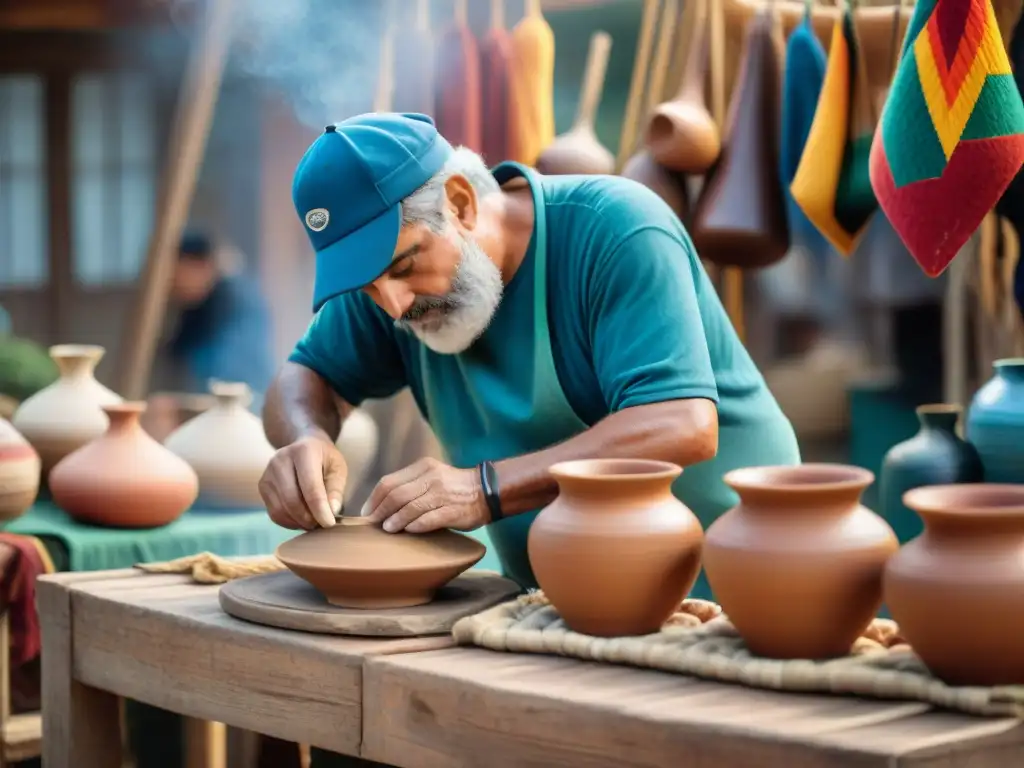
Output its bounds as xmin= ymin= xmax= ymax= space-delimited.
xmin=790 ymin=0 xmax=878 ymax=256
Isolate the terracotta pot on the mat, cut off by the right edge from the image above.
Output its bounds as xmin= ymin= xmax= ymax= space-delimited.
xmin=884 ymin=483 xmax=1024 ymax=685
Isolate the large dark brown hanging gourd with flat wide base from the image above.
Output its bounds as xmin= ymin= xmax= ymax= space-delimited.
xmin=691 ymin=8 xmax=790 ymax=268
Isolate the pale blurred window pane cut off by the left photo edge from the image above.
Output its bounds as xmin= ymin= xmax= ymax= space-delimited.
xmin=0 ymin=75 xmax=49 ymax=290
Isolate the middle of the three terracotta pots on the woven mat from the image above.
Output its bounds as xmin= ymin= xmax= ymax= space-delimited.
xmin=703 ymin=464 xmax=898 ymax=658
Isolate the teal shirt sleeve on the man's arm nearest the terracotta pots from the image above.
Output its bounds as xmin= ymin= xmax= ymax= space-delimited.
xmin=587 ymin=226 xmax=718 ymax=412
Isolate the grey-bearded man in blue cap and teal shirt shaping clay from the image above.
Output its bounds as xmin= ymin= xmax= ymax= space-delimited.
xmin=260 ymin=114 xmax=800 ymax=587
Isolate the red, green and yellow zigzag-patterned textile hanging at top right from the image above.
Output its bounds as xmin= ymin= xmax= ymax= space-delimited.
xmin=870 ymin=0 xmax=1024 ymax=278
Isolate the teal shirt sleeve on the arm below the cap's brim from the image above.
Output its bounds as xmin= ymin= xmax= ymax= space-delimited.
xmin=288 ymin=292 xmax=408 ymax=406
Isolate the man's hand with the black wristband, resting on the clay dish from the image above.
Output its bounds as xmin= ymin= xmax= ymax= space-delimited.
xmin=362 ymin=459 xmax=490 ymax=534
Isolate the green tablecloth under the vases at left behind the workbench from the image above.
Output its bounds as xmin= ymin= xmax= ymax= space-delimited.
xmin=0 ymin=501 xmax=295 ymax=570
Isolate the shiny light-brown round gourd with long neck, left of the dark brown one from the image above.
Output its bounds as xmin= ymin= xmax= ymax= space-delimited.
xmin=645 ymin=0 xmax=722 ymax=174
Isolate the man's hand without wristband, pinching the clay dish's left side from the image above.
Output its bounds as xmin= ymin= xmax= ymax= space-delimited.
xmin=259 ymin=434 xmax=348 ymax=530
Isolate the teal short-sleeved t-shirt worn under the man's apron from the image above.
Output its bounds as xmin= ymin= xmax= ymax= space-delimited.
xmin=290 ymin=176 xmax=800 ymax=525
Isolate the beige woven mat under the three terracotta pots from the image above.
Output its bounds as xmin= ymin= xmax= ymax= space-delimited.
xmin=452 ymin=592 xmax=1024 ymax=717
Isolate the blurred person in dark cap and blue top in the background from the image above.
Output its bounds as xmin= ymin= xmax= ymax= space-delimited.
xmin=146 ymin=231 xmax=274 ymax=438
